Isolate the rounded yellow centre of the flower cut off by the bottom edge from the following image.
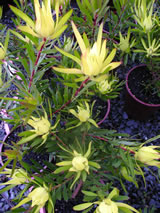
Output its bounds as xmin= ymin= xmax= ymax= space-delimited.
xmin=96 ymin=198 xmax=118 ymax=213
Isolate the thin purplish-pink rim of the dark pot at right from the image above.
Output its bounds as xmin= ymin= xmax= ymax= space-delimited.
xmin=126 ymin=64 xmax=160 ymax=108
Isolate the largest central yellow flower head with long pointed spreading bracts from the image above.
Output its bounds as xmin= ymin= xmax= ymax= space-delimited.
xmin=53 ymin=22 xmax=121 ymax=81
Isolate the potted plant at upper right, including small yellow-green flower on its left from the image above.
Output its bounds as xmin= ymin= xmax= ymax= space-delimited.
xmin=115 ymin=0 xmax=160 ymax=96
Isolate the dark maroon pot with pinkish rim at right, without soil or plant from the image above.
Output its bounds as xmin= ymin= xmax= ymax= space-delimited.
xmin=125 ymin=64 xmax=160 ymax=120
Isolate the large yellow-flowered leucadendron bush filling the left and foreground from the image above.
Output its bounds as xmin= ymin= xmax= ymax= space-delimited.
xmin=0 ymin=0 xmax=159 ymax=213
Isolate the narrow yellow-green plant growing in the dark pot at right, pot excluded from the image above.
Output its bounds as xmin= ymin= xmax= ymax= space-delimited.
xmin=133 ymin=0 xmax=160 ymax=96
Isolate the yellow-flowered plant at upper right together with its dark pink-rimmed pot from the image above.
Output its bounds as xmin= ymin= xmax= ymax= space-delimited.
xmin=119 ymin=0 xmax=160 ymax=120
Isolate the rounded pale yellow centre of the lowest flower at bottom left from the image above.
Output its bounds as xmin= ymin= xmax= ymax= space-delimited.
xmin=28 ymin=187 xmax=49 ymax=208
